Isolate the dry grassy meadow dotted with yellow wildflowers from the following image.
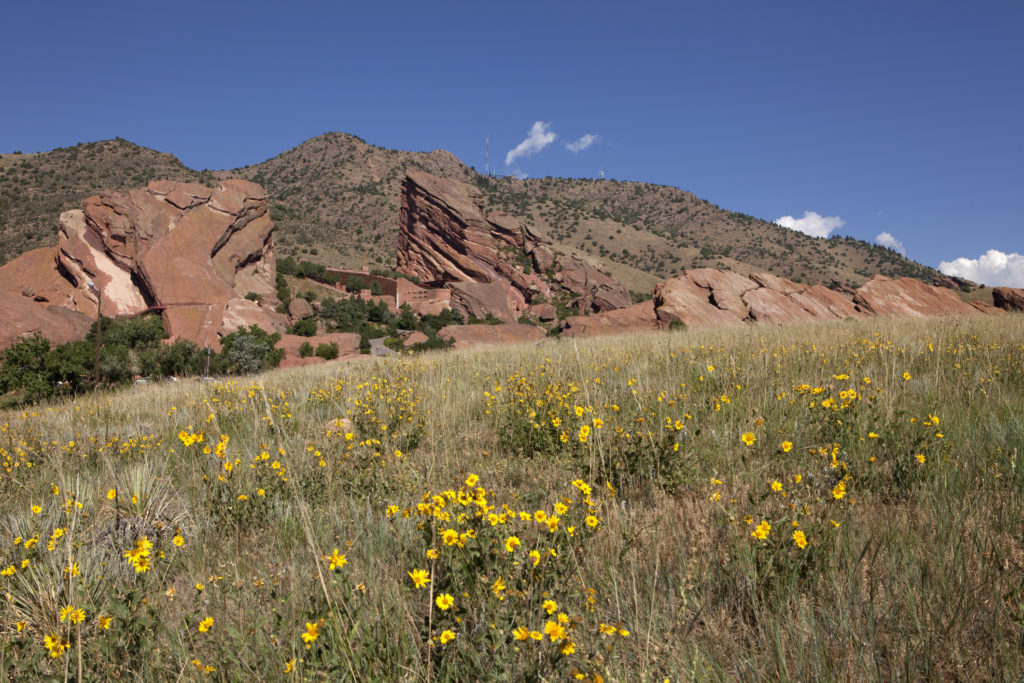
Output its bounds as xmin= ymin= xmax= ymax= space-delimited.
xmin=0 ymin=315 xmax=1024 ymax=681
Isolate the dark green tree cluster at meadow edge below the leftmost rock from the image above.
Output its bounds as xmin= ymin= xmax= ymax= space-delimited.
xmin=0 ymin=315 xmax=284 ymax=404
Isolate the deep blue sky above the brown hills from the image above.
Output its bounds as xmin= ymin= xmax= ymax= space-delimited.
xmin=6 ymin=0 xmax=1024 ymax=287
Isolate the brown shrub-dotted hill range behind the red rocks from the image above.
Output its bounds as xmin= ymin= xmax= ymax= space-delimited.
xmin=0 ymin=133 xmax=942 ymax=292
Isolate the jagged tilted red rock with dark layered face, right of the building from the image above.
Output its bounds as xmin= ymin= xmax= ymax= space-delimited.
xmin=397 ymin=172 xmax=630 ymax=323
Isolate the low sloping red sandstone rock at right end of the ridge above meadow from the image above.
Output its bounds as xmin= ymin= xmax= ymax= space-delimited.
xmin=854 ymin=275 xmax=978 ymax=317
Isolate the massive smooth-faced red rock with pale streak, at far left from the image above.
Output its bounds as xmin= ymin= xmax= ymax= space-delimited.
xmin=0 ymin=180 xmax=284 ymax=348
